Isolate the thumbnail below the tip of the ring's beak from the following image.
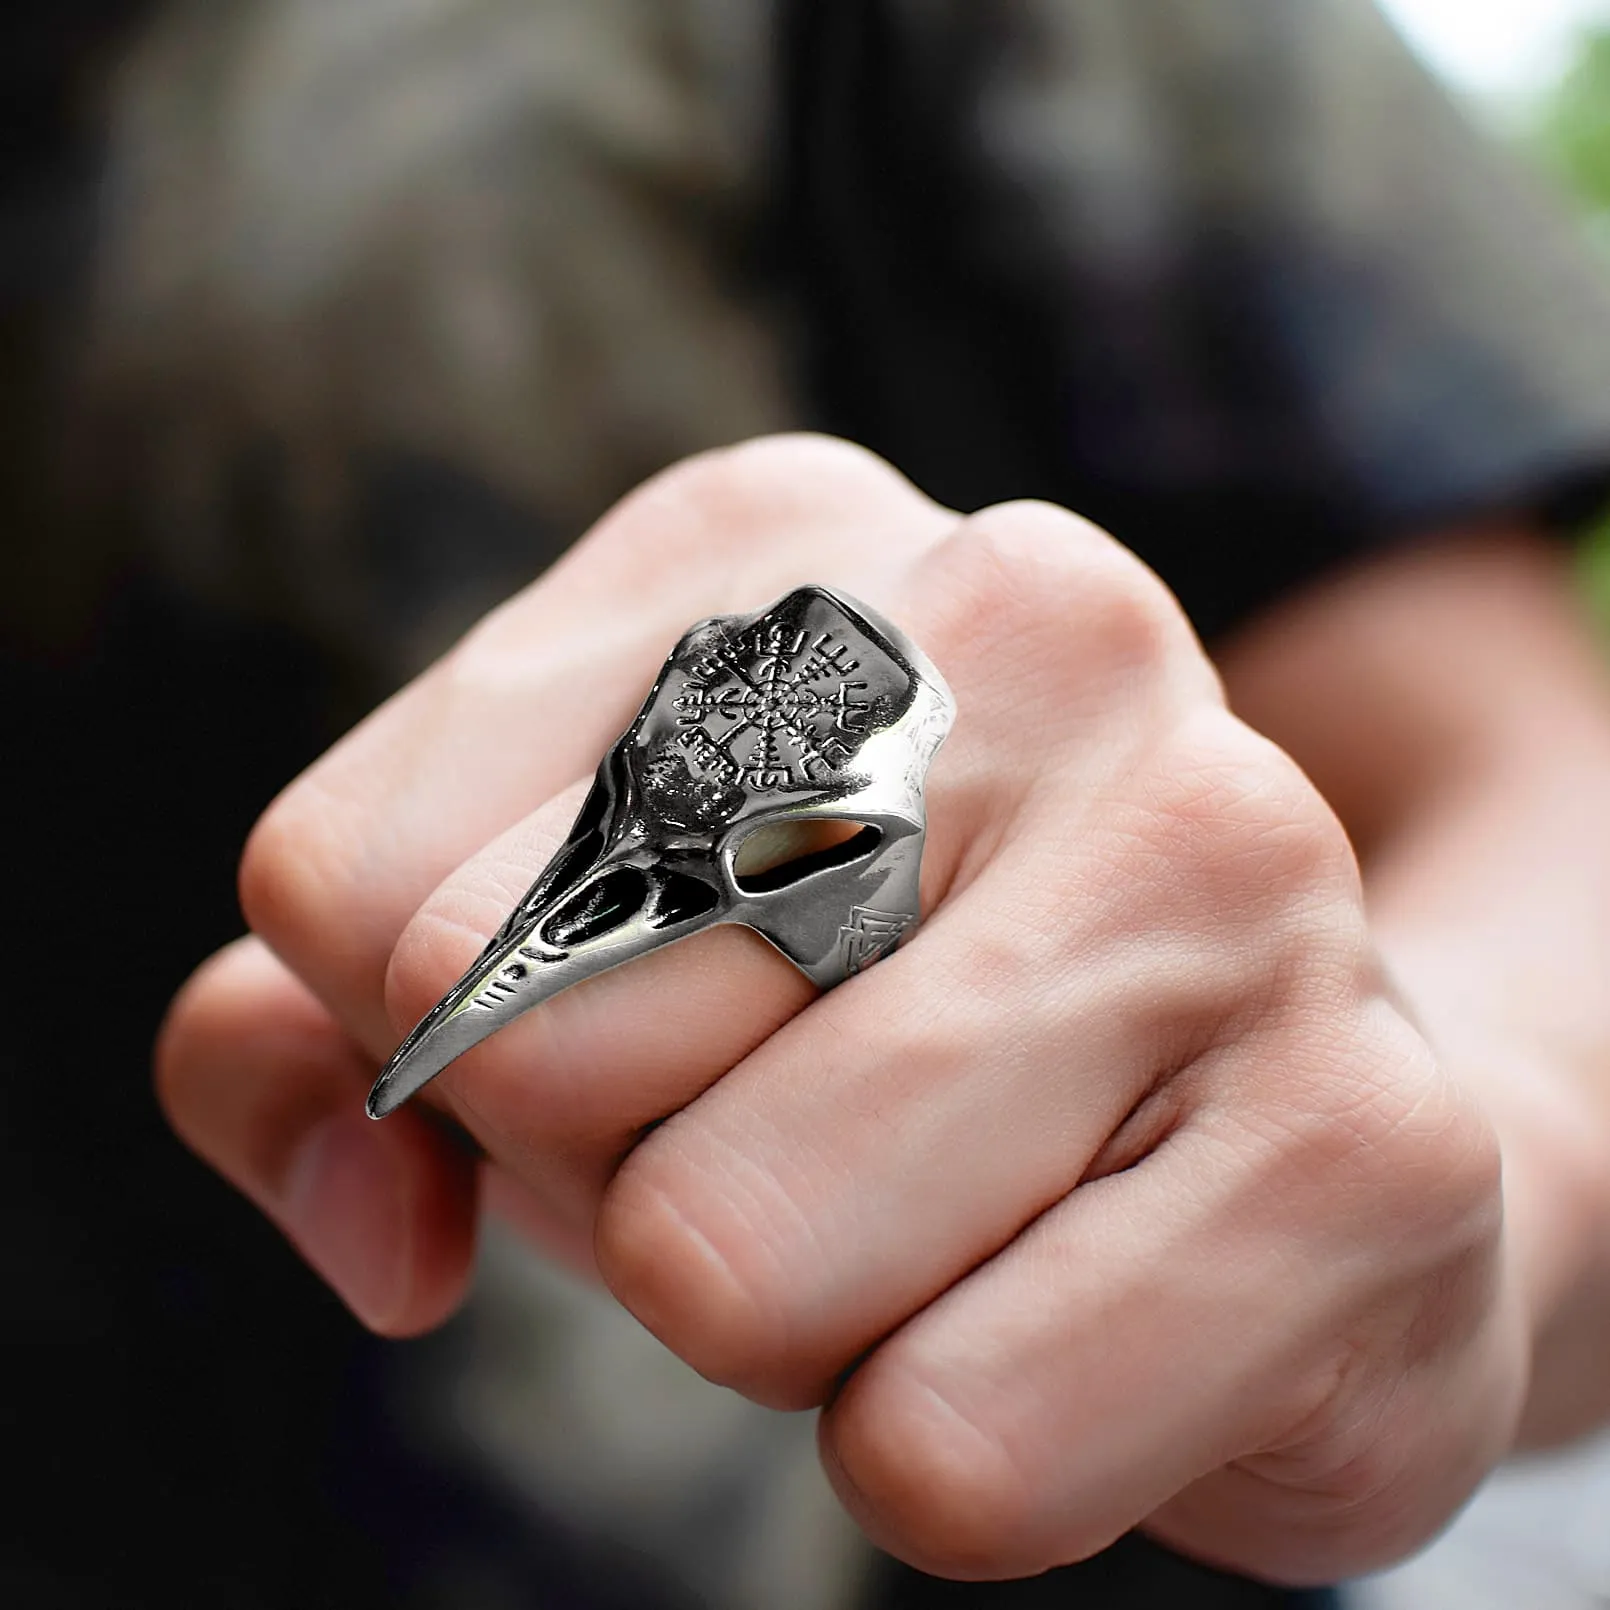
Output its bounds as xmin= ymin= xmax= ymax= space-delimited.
xmin=283 ymin=1113 xmax=409 ymax=1330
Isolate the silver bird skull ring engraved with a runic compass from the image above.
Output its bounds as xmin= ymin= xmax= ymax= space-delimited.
xmin=369 ymin=586 xmax=956 ymax=1117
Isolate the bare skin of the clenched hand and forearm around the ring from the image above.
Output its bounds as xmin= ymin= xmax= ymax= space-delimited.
xmin=158 ymin=438 xmax=1610 ymax=1581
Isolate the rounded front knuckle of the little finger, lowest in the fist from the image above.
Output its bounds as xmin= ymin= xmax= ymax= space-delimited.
xmin=823 ymin=1356 xmax=1051 ymax=1579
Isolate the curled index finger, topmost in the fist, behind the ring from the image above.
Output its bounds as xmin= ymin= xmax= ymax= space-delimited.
xmin=240 ymin=438 xmax=953 ymax=1056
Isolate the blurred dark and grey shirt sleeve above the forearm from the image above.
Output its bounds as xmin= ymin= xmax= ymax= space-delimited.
xmin=779 ymin=0 xmax=1610 ymax=638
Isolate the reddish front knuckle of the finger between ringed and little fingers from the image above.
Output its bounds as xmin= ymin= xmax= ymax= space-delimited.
xmin=594 ymin=1148 xmax=821 ymax=1409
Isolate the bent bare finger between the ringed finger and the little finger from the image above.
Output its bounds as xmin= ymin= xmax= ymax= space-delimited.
xmin=597 ymin=707 xmax=1306 ymax=1406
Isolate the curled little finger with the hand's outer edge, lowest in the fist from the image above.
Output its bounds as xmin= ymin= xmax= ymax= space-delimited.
xmin=821 ymin=1000 xmax=1523 ymax=1583
